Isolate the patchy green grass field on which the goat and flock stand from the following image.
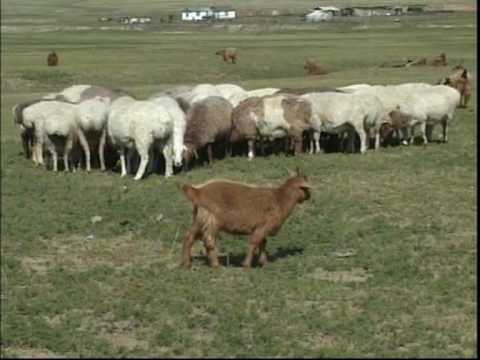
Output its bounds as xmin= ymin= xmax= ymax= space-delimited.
xmin=1 ymin=0 xmax=478 ymax=358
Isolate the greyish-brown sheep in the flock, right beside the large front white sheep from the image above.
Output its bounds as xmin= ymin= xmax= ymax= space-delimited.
xmin=184 ymin=96 xmax=232 ymax=170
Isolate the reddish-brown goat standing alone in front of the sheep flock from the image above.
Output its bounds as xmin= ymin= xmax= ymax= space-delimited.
xmin=181 ymin=169 xmax=311 ymax=269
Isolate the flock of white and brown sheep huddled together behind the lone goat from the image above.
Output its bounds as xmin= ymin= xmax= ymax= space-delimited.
xmin=13 ymin=67 xmax=471 ymax=180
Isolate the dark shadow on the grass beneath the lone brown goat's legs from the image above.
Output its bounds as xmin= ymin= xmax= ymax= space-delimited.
xmin=192 ymin=246 xmax=303 ymax=268
